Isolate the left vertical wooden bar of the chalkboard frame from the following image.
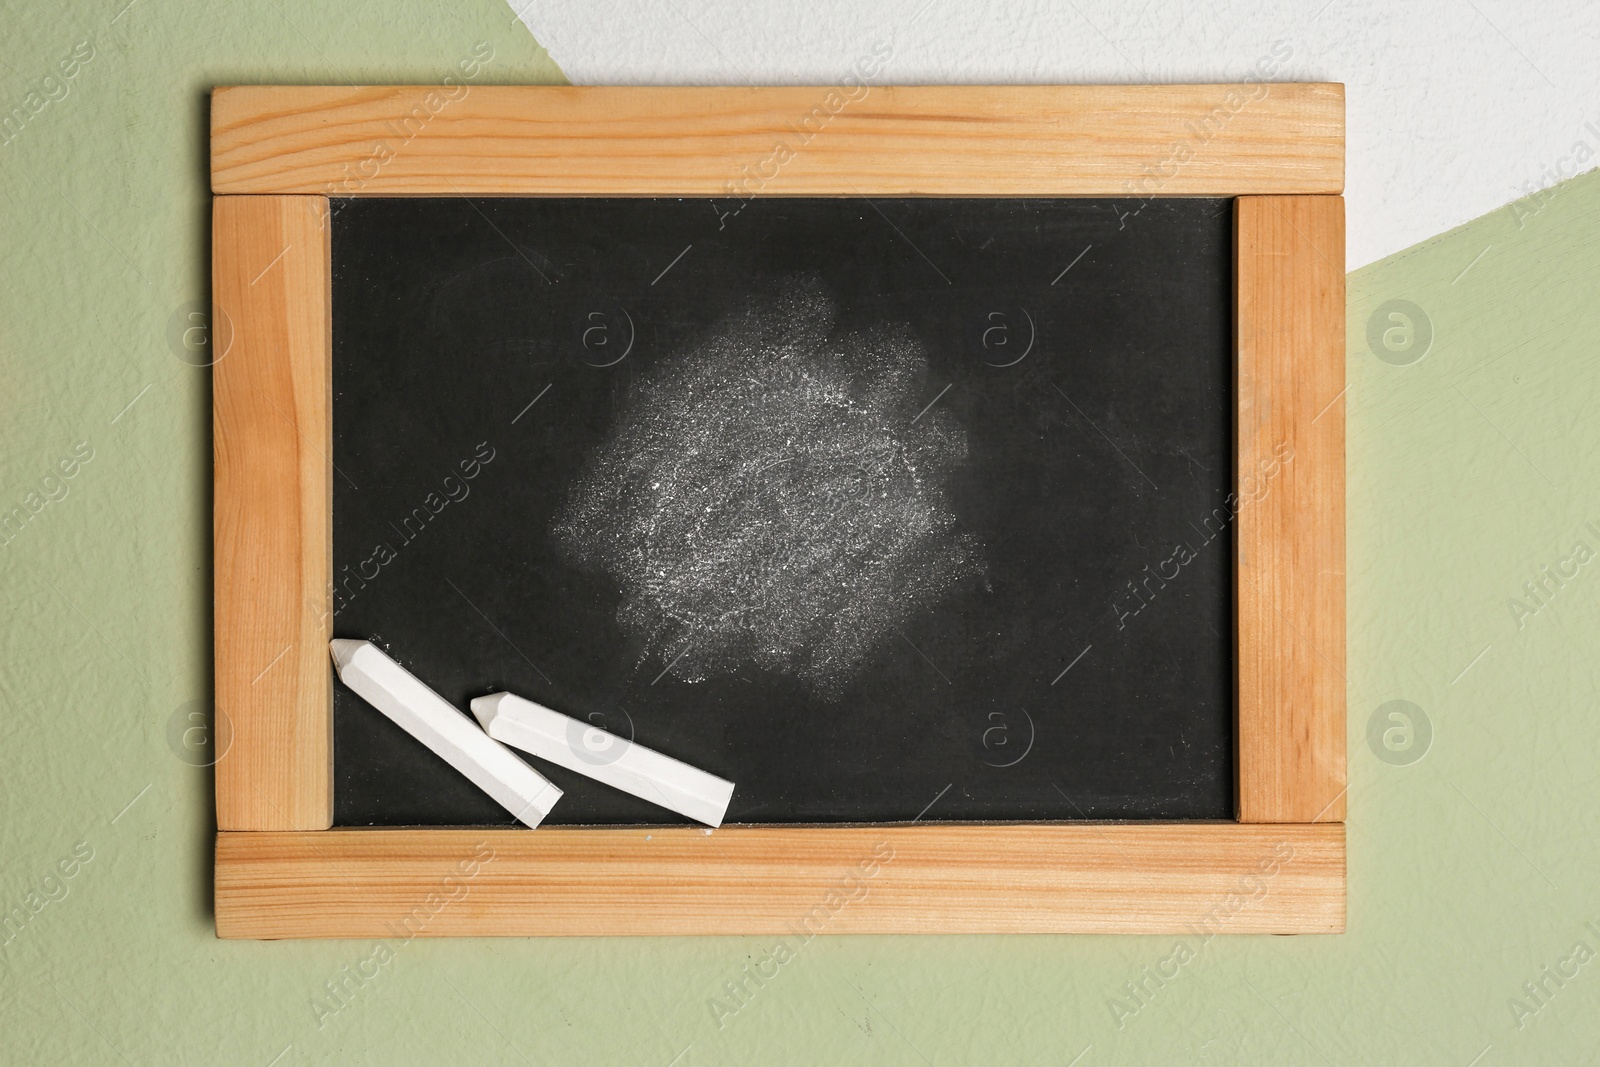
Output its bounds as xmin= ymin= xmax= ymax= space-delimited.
xmin=211 ymin=197 xmax=333 ymax=830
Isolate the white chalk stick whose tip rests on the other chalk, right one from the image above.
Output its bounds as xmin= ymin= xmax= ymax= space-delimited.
xmin=472 ymin=693 xmax=733 ymax=825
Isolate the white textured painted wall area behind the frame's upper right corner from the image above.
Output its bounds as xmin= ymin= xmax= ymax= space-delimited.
xmin=510 ymin=0 xmax=1600 ymax=267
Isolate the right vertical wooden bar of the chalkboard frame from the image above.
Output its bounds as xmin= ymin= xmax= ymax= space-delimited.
xmin=1235 ymin=197 xmax=1346 ymax=822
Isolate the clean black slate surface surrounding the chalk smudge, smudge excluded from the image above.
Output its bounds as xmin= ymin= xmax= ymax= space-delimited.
xmin=333 ymin=198 xmax=1234 ymax=825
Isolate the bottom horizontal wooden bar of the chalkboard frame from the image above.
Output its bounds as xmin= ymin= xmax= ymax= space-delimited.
xmin=216 ymin=824 xmax=1344 ymax=939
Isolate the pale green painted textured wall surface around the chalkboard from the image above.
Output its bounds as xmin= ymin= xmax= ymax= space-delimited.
xmin=0 ymin=0 xmax=1600 ymax=1067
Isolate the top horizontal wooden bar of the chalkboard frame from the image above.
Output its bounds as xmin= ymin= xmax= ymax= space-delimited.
xmin=211 ymin=83 xmax=1344 ymax=198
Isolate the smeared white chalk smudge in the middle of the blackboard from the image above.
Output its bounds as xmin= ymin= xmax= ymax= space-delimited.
xmin=554 ymin=282 xmax=984 ymax=697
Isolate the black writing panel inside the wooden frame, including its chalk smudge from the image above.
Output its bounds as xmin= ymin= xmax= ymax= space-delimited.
xmin=331 ymin=197 xmax=1234 ymax=825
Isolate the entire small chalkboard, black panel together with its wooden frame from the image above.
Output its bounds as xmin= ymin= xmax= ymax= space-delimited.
xmin=210 ymin=85 xmax=1346 ymax=937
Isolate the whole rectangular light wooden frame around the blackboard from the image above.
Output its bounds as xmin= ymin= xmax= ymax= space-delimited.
xmin=211 ymin=83 xmax=1346 ymax=937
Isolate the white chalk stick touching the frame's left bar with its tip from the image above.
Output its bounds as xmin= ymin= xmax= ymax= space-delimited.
xmin=328 ymin=638 xmax=562 ymax=827
